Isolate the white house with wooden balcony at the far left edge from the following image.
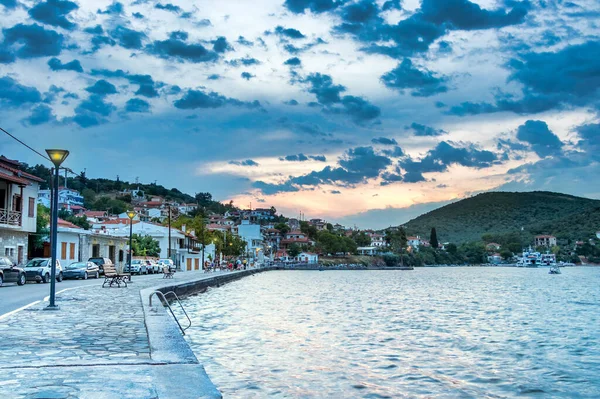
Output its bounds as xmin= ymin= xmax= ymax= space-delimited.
xmin=0 ymin=156 xmax=44 ymax=264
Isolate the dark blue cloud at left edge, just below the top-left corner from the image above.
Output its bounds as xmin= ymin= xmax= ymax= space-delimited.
xmin=1 ymin=24 xmax=64 ymax=58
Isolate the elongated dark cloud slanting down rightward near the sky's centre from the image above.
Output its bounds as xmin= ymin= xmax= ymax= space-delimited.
xmin=302 ymin=73 xmax=381 ymax=123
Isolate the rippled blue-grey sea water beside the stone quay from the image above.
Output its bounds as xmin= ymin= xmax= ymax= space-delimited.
xmin=184 ymin=268 xmax=600 ymax=398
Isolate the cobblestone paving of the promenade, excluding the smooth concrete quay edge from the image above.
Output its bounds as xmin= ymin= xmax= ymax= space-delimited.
xmin=0 ymin=272 xmax=239 ymax=399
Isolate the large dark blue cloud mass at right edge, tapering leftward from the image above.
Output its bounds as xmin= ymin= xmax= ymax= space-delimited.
xmin=447 ymin=41 xmax=600 ymax=116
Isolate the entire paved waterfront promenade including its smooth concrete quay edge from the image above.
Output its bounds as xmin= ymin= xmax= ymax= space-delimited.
xmin=0 ymin=272 xmax=254 ymax=399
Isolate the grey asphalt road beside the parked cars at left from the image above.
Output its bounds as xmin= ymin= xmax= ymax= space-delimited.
xmin=0 ymin=274 xmax=162 ymax=317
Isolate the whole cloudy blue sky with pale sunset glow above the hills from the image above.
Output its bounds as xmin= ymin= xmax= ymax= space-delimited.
xmin=0 ymin=0 xmax=600 ymax=228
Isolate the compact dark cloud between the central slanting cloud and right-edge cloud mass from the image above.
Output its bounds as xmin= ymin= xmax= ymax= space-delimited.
xmin=381 ymin=58 xmax=448 ymax=97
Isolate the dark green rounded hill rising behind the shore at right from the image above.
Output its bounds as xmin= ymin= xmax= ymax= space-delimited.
xmin=404 ymin=191 xmax=600 ymax=244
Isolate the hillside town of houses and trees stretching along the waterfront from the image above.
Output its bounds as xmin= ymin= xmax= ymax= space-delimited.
xmin=0 ymin=156 xmax=600 ymax=271
